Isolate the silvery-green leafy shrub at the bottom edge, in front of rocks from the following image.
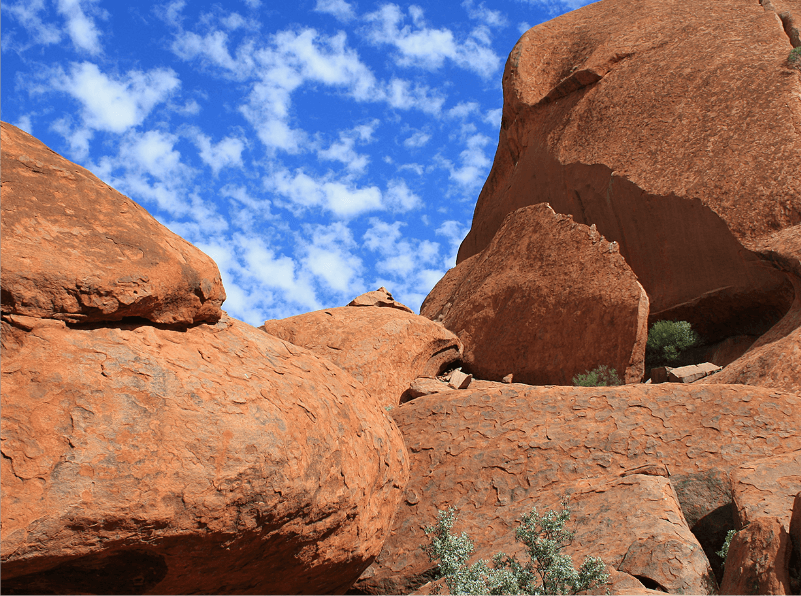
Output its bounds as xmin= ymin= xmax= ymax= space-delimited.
xmin=423 ymin=503 xmax=609 ymax=594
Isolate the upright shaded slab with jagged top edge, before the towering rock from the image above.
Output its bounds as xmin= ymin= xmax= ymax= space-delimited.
xmin=420 ymin=204 xmax=648 ymax=385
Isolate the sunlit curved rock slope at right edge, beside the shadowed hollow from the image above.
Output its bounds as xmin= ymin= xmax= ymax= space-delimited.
xmin=700 ymin=225 xmax=801 ymax=391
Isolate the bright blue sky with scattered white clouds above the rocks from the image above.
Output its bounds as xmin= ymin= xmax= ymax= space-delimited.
xmin=2 ymin=0 xmax=588 ymax=325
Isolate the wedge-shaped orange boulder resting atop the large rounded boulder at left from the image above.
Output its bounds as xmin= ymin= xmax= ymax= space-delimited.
xmin=0 ymin=123 xmax=225 ymax=325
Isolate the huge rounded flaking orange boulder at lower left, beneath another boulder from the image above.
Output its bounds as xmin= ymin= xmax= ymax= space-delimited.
xmin=2 ymin=318 xmax=408 ymax=594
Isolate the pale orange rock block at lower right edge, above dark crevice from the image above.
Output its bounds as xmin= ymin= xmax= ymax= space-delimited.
xmin=731 ymin=451 xmax=801 ymax=531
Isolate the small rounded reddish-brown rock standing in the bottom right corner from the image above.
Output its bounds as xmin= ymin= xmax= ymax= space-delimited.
xmin=720 ymin=517 xmax=792 ymax=594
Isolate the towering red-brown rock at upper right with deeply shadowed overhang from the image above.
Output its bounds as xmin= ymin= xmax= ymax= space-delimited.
xmin=457 ymin=0 xmax=801 ymax=340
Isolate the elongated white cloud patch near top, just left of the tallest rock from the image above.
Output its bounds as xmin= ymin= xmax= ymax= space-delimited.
xmin=364 ymin=4 xmax=501 ymax=78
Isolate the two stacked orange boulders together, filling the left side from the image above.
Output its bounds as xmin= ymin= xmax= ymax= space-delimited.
xmin=2 ymin=124 xmax=410 ymax=594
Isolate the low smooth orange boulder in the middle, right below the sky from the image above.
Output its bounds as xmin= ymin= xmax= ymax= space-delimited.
xmin=261 ymin=306 xmax=462 ymax=407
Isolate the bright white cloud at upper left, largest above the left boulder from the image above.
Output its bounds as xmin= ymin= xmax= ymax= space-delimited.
xmin=53 ymin=62 xmax=181 ymax=133
